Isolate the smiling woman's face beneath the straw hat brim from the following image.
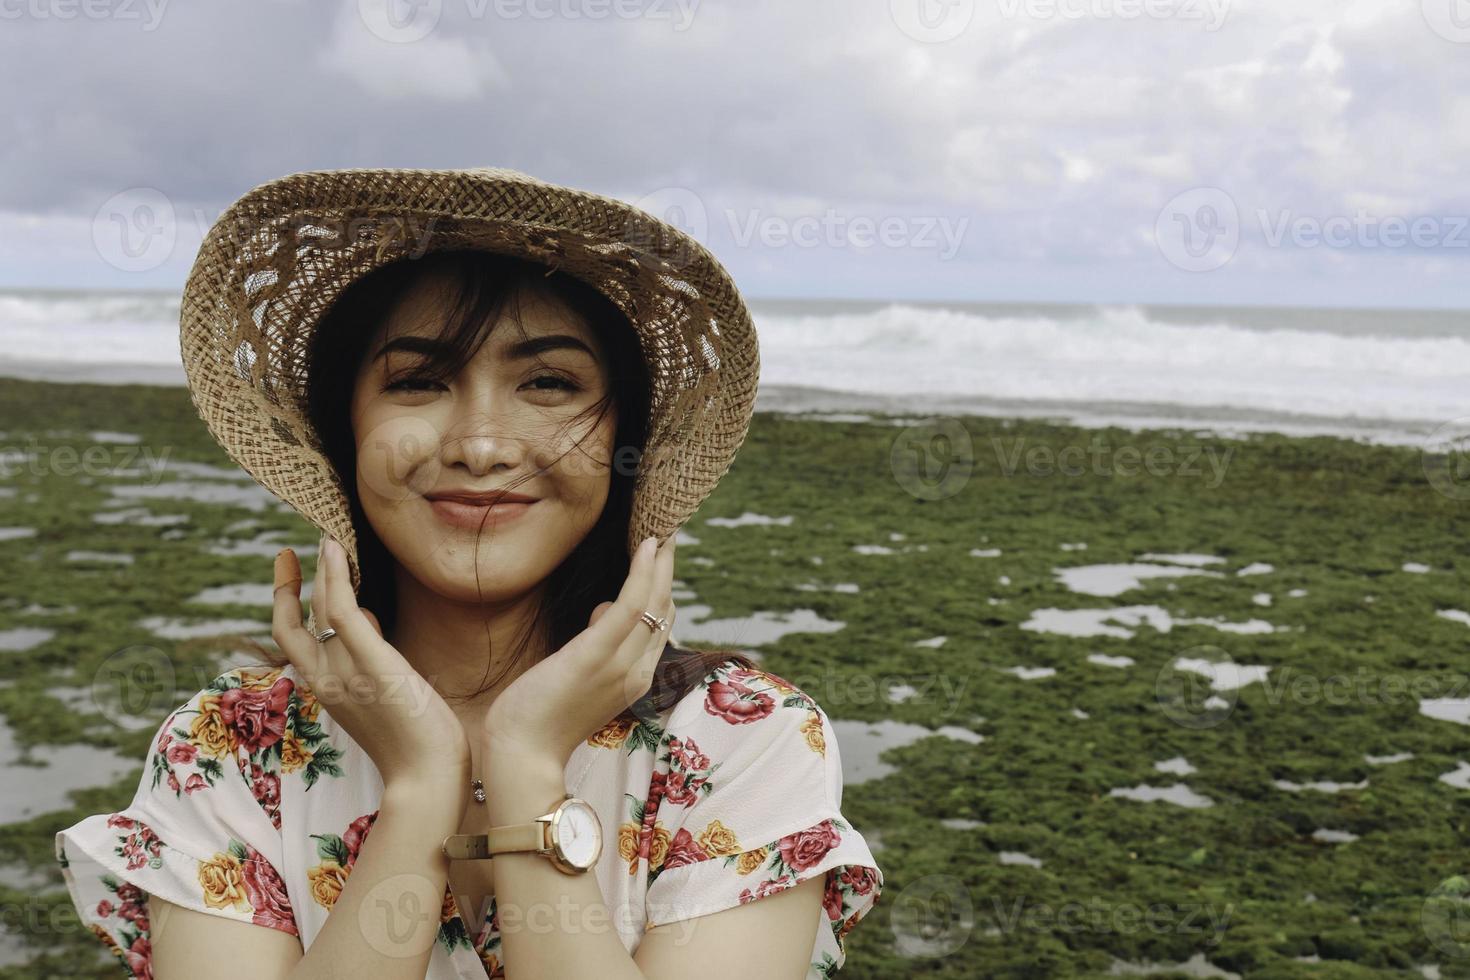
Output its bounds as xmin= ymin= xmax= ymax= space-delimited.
xmin=351 ymin=270 xmax=617 ymax=602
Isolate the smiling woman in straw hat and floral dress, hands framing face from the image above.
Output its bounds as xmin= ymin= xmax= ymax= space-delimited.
xmin=57 ymin=170 xmax=882 ymax=980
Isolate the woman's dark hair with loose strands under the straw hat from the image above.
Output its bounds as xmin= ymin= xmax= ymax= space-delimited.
xmin=238 ymin=248 xmax=756 ymax=721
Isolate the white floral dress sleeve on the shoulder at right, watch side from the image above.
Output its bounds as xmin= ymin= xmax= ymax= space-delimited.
xmin=642 ymin=661 xmax=883 ymax=977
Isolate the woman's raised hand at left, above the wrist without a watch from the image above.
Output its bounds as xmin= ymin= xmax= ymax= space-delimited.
xmin=270 ymin=539 xmax=470 ymax=820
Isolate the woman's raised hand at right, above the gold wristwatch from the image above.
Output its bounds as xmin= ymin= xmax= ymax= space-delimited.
xmin=482 ymin=533 xmax=678 ymax=782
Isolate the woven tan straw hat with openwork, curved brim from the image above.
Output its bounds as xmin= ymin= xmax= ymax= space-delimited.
xmin=179 ymin=167 xmax=760 ymax=592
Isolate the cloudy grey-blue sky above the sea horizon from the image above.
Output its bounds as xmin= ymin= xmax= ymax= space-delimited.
xmin=0 ymin=0 xmax=1470 ymax=309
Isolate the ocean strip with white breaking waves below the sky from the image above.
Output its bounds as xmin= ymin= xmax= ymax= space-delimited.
xmin=0 ymin=289 xmax=1470 ymax=444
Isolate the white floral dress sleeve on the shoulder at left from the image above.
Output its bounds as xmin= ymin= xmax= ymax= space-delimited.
xmin=56 ymin=667 xmax=298 ymax=980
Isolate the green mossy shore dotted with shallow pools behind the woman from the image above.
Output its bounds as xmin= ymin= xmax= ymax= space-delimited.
xmin=0 ymin=379 xmax=1470 ymax=980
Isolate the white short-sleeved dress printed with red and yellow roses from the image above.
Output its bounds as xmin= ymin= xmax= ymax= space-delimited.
xmin=56 ymin=661 xmax=883 ymax=980
